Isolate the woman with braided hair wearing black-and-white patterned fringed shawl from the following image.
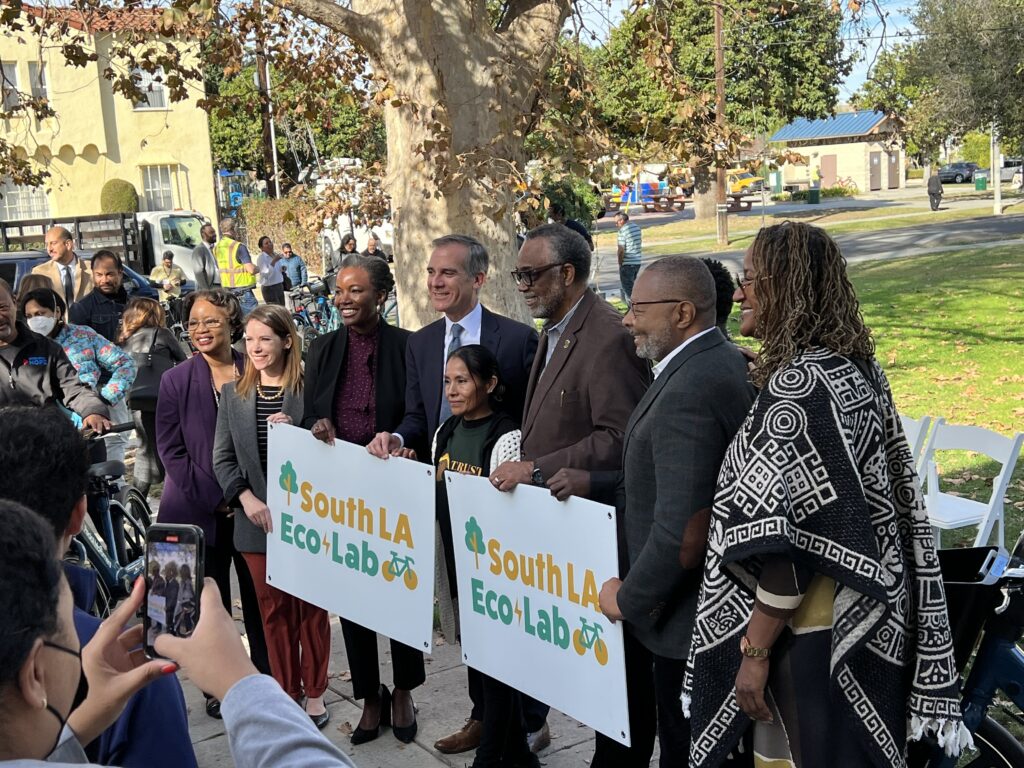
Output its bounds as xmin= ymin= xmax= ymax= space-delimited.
xmin=683 ymin=222 xmax=971 ymax=768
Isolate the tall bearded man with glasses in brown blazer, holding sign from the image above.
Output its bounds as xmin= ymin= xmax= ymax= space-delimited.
xmin=490 ymin=224 xmax=651 ymax=766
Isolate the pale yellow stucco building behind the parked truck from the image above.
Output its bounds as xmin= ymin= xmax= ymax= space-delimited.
xmin=0 ymin=6 xmax=217 ymax=221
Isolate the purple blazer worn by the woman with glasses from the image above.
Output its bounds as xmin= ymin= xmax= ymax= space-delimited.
xmin=157 ymin=352 xmax=245 ymax=545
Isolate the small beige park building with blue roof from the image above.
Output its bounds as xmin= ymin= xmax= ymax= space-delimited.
xmin=768 ymin=110 xmax=905 ymax=191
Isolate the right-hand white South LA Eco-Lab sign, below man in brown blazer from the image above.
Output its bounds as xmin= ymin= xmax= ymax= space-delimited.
xmin=444 ymin=472 xmax=630 ymax=745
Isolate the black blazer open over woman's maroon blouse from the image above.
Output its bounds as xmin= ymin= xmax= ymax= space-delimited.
xmin=302 ymin=321 xmax=415 ymax=447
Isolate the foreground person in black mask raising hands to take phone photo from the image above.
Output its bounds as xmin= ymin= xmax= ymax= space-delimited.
xmin=0 ymin=500 xmax=352 ymax=768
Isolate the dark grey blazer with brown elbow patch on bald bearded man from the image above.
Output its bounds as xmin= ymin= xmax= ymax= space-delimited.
xmin=618 ymin=329 xmax=754 ymax=659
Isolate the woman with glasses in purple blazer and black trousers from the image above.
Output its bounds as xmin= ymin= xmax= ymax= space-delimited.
xmin=157 ymin=289 xmax=270 ymax=718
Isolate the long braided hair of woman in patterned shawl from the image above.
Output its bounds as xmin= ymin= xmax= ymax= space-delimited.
xmin=751 ymin=221 xmax=874 ymax=387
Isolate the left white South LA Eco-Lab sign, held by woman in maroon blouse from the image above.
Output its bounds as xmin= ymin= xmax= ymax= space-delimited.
xmin=266 ymin=424 xmax=435 ymax=653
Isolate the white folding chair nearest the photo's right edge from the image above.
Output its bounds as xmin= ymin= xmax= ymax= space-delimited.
xmin=923 ymin=420 xmax=1024 ymax=548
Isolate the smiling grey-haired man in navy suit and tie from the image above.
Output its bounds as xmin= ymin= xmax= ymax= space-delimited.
xmin=367 ymin=234 xmax=550 ymax=755
